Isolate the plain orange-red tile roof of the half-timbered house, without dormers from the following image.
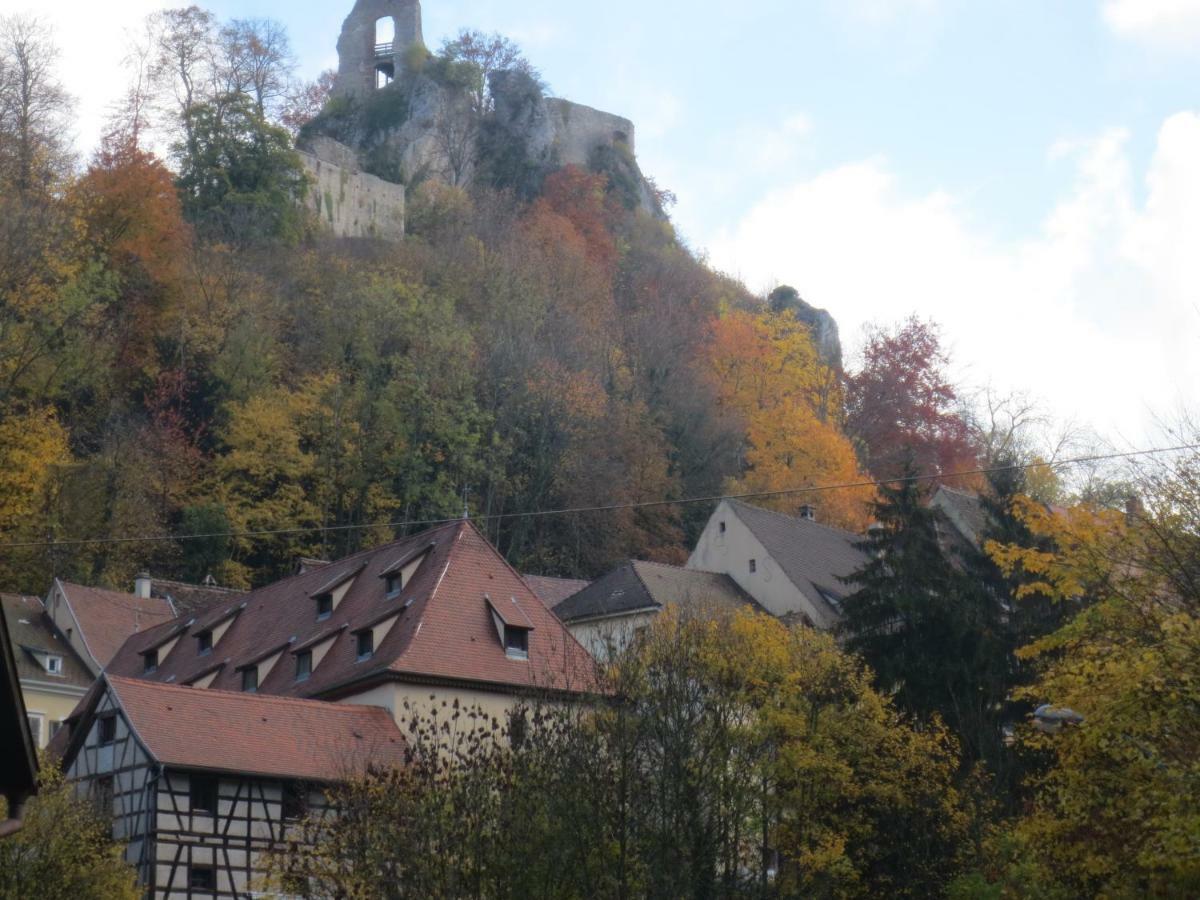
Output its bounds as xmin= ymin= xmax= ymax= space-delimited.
xmin=108 ymin=676 xmax=404 ymax=781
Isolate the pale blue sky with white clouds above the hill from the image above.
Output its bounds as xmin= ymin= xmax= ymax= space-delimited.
xmin=9 ymin=0 xmax=1200 ymax=448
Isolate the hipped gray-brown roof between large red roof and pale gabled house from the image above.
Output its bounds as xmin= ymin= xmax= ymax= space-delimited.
xmin=554 ymin=559 xmax=762 ymax=622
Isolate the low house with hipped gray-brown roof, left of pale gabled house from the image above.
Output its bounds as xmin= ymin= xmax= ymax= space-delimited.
xmin=554 ymin=559 xmax=762 ymax=660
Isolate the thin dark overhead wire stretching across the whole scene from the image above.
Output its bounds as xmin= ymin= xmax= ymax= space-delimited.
xmin=0 ymin=444 xmax=1200 ymax=551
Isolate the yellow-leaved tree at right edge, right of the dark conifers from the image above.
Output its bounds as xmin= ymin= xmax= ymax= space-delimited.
xmin=978 ymin=439 xmax=1200 ymax=896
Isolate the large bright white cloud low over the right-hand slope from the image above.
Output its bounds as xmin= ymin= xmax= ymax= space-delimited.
xmin=712 ymin=113 xmax=1200 ymax=439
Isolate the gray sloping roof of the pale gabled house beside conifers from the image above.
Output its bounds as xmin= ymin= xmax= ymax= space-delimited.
xmin=728 ymin=500 xmax=868 ymax=626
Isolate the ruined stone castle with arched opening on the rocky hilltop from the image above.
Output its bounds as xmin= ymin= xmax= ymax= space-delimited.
xmin=298 ymin=0 xmax=656 ymax=240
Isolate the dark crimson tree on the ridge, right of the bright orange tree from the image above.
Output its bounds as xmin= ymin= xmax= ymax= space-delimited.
xmin=846 ymin=317 xmax=977 ymax=487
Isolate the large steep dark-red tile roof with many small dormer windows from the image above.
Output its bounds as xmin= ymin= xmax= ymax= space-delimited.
xmin=110 ymin=522 xmax=595 ymax=697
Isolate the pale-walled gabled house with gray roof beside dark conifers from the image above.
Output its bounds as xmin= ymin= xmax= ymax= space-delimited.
xmin=688 ymin=500 xmax=866 ymax=630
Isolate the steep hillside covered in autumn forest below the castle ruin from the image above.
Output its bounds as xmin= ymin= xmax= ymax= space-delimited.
xmin=0 ymin=7 xmax=998 ymax=592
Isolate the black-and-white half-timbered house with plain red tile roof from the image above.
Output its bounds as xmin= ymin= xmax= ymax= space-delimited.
xmin=55 ymin=674 xmax=406 ymax=899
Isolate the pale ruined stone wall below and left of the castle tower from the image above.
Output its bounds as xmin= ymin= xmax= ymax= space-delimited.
xmin=300 ymin=138 xmax=404 ymax=240
